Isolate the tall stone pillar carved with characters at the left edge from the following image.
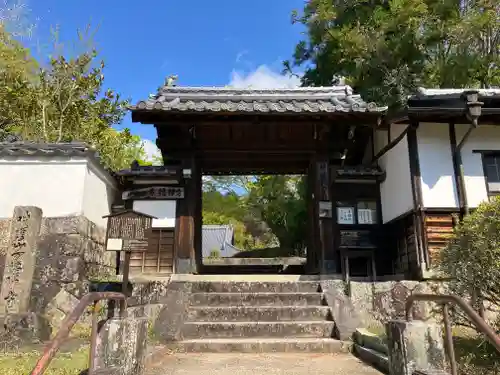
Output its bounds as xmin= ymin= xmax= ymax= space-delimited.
xmin=0 ymin=206 xmax=42 ymax=316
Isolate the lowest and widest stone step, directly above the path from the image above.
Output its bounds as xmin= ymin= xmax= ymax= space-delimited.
xmin=169 ymin=337 xmax=352 ymax=354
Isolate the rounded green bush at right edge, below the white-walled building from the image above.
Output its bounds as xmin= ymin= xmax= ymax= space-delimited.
xmin=440 ymin=197 xmax=500 ymax=328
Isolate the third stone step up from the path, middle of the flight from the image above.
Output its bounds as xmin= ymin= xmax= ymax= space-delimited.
xmin=187 ymin=306 xmax=330 ymax=322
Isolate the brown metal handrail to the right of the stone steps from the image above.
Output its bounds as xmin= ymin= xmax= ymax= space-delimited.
xmin=405 ymin=294 xmax=500 ymax=375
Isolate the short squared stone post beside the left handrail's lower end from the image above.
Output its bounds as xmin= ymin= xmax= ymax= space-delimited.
xmin=94 ymin=318 xmax=148 ymax=375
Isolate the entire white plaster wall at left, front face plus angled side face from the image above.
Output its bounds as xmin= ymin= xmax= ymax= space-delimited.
xmin=0 ymin=157 xmax=116 ymax=226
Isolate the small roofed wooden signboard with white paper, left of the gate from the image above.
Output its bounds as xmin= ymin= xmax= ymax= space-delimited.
xmin=105 ymin=210 xmax=155 ymax=252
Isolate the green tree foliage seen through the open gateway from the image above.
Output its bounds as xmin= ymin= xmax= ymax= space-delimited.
xmin=203 ymin=176 xmax=307 ymax=255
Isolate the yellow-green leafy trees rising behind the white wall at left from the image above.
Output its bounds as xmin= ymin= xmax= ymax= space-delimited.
xmin=0 ymin=21 xmax=145 ymax=170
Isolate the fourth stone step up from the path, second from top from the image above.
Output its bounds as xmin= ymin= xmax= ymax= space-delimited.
xmin=191 ymin=292 xmax=323 ymax=306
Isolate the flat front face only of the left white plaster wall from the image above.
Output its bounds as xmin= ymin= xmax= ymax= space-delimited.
xmin=0 ymin=158 xmax=87 ymax=217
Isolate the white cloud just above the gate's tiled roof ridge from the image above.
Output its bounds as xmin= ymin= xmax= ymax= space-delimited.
xmin=229 ymin=65 xmax=300 ymax=89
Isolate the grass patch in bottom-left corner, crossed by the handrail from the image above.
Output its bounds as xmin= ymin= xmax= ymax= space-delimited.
xmin=0 ymin=347 xmax=89 ymax=375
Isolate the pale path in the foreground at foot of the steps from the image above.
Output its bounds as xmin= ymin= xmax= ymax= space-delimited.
xmin=146 ymin=353 xmax=381 ymax=375
